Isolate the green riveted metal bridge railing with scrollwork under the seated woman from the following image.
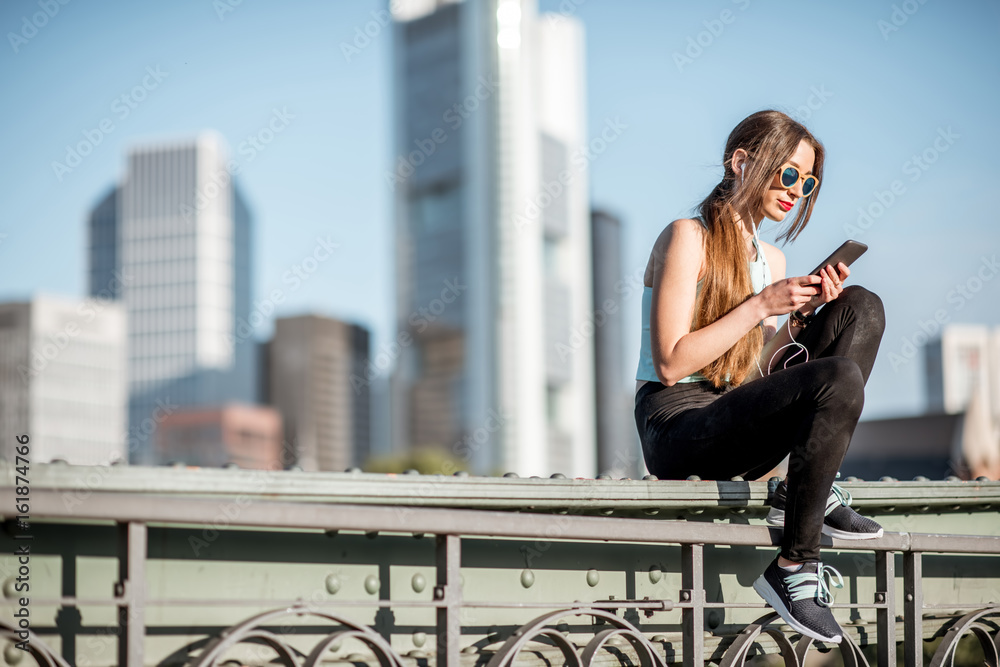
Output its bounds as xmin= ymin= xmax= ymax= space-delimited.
xmin=0 ymin=465 xmax=1000 ymax=667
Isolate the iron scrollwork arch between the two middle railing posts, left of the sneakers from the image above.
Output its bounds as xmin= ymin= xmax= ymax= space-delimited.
xmin=486 ymin=607 xmax=666 ymax=667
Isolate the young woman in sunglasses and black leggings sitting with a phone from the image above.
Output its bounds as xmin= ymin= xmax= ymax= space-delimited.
xmin=635 ymin=111 xmax=885 ymax=643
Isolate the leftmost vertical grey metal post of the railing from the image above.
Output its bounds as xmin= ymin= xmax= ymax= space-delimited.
xmin=115 ymin=521 xmax=146 ymax=665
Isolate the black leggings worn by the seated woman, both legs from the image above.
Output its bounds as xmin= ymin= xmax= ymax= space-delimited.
xmin=635 ymin=285 xmax=885 ymax=561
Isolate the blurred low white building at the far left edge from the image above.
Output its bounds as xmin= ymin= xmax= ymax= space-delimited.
xmin=0 ymin=296 xmax=127 ymax=465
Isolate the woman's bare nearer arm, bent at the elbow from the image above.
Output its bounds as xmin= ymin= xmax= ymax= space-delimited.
xmin=649 ymin=219 xmax=768 ymax=386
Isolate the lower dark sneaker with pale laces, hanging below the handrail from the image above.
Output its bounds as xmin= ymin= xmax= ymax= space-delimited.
xmin=753 ymin=558 xmax=844 ymax=644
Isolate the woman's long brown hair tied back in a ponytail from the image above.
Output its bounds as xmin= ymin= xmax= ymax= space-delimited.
xmin=695 ymin=110 xmax=823 ymax=388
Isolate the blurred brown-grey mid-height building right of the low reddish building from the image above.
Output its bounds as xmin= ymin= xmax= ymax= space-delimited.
xmin=266 ymin=315 xmax=371 ymax=472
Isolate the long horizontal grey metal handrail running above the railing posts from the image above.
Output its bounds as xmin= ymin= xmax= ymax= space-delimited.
xmin=13 ymin=490 xmax=1000 ymax=554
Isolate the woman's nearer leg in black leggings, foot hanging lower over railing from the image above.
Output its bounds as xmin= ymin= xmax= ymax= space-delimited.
xmin=643 ymin=357 xmax=864 ymax=561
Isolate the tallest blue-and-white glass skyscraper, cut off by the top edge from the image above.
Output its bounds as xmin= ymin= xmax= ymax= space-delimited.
xmin=385 ymin=0 xmax=596 ymax=476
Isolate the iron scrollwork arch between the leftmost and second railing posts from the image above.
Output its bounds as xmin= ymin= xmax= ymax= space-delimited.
xmin=188 ymin=605 xmax=403 ymax=667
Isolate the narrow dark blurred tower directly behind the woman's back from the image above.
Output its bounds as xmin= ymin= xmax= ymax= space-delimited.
xmin=590 ymin=209 xmax=642 ymax=477
